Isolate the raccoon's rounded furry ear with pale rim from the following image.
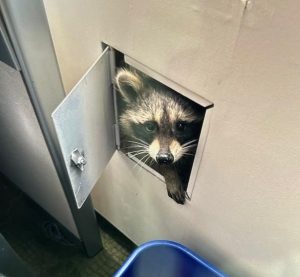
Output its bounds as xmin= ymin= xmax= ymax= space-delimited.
xmin=116 ymin=69 xmax=143 ymax=103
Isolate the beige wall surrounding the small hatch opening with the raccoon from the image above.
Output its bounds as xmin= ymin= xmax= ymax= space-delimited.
xmin=44 ymin=0 xmax=300 ymax=277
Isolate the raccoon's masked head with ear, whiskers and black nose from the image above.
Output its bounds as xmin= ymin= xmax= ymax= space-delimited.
xmin=116 ymin=69 xmax=203 ymax=165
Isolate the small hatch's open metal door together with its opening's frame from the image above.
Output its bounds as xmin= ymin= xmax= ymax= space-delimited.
xmin=52 ymin=44 xmax=212 ymax=208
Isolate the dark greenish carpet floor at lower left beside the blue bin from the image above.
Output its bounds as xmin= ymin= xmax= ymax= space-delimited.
xmin=0 ymin=174 xmax=135 ymax=277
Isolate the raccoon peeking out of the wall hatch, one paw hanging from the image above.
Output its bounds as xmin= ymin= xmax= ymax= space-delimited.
xmin=116 ymin=68 xmax=204 ymax=204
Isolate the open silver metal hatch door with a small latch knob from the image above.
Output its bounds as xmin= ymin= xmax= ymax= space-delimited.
xmin=52 ymin=48 xmax=116 ymax=208
